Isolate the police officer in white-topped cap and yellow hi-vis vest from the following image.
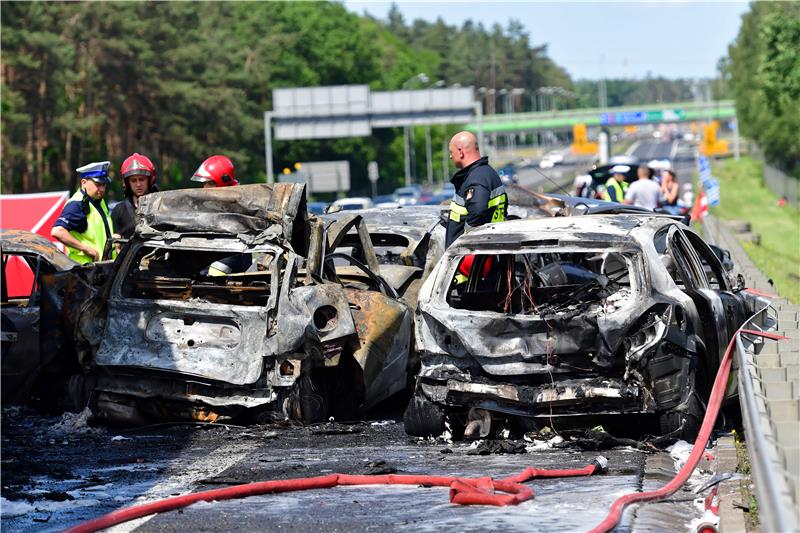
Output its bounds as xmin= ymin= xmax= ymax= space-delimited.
xmin=50 ymin=161 xmax=114 ymax=263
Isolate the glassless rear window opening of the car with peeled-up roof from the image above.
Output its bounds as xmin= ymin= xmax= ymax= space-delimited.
xmin=122 ymin=246 xmax=275 ymax=305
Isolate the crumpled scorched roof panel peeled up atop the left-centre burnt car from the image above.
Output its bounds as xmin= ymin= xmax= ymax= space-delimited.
xmin=136 ymin=183 xmax=309 ymax=255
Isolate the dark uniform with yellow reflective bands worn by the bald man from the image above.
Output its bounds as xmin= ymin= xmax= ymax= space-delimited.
xmin=446 ymin=157 xmax=508 ymax=246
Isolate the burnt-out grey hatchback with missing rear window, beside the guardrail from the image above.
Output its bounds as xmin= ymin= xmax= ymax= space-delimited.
xmin=404 ymin=214 xmax=746 ymax=439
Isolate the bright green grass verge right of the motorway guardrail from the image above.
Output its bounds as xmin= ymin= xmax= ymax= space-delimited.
xmin=711 ymin=157 xmax=800 ymax=303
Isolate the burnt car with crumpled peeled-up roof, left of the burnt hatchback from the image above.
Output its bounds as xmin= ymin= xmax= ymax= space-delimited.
xmin=52 ymin=184 xmax=412 ymax=423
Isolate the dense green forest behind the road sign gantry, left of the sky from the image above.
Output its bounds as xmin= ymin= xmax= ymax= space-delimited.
xmin=0 ymin=2 xmax=740 ymax=197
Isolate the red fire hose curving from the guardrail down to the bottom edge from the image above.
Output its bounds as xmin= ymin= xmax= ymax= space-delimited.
xmin=589 ymin=315 xmax=785 ymax=533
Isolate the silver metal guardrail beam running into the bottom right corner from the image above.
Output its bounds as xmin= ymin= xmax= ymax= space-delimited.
xmin=735 ymin=296 xmax=800 ymax=532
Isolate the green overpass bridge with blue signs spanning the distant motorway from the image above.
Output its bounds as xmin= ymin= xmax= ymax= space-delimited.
xmin=467 ymin=100 xmax=736 ymax=133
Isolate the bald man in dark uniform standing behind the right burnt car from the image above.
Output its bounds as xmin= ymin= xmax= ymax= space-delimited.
xmin=445 ymin=131 xmax=508 ymax=246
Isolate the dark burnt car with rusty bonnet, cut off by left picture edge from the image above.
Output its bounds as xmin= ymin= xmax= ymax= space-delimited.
xmin=0 ymin=230 xmax=78 ymax=405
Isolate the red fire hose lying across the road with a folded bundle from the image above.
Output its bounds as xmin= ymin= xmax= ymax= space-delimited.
xmin=67 ymin=458 xmax=605 ymax=533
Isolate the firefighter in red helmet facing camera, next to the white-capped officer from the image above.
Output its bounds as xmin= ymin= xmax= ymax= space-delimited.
xmin=111 ymin=153 xmax=158 ymax=239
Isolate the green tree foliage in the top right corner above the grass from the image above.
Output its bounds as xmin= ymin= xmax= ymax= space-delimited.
xmin=725 ymin=2 xmax=800 ymax=174
